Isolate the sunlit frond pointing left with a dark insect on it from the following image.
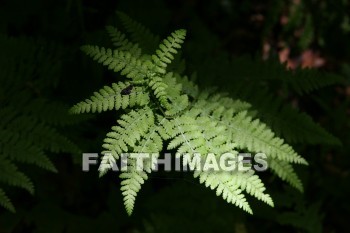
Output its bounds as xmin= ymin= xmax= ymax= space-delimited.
xmin=71 ymin=82 xmax=149 ymax=114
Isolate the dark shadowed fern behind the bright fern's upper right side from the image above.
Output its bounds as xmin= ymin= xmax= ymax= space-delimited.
xmin=200 ymin=54 xmax=342 ymax=145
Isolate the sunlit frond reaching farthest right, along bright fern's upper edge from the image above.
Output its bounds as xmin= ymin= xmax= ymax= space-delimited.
xmin=189 ymin=92 xmax=307 ymax=164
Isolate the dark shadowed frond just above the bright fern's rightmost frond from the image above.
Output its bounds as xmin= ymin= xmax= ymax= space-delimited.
xmin=236 ymin=87 xmax=341 ymax=145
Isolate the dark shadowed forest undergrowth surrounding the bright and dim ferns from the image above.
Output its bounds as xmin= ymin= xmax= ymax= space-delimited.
xmin=0 ymin=0 xmax=350 ymax=233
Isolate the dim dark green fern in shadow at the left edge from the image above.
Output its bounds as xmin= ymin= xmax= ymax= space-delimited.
xmin=0 ymin=35 xmax=81 ymax=212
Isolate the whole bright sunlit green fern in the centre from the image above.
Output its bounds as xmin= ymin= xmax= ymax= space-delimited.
xmin=71 ymin=13 xmax=338 ymax=214
